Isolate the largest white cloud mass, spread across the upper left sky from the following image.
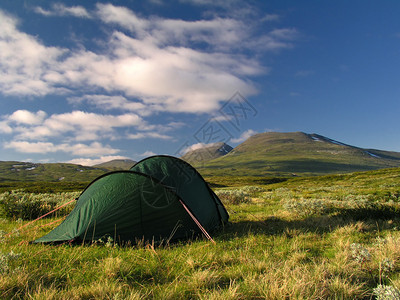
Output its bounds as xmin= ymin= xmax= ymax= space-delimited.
xmin=0 ymin=4 xmax=296 ymax=115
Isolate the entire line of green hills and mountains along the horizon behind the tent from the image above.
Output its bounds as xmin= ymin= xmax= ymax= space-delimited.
xmin=0 ymin=132 xmax=400 ymax=182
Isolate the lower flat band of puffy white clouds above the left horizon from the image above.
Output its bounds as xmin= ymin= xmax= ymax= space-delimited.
xmin=0 ymin=110 xmax=177 ymax=148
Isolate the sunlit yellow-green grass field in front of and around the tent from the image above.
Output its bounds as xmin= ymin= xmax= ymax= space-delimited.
xmin=0 ymin=169 xmax=400 ymax=299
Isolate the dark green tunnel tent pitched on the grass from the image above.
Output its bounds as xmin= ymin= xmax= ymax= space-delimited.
xmin=34 ymin=156 xmax=229 ymax=243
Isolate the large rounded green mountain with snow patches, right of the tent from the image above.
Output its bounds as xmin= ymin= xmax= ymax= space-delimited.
xmin=198 ymin=132 xmax=400 ymax=176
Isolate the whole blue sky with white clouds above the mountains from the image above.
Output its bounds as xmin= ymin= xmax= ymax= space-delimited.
xmin=0 ymin=0 xmax=400 ymax=165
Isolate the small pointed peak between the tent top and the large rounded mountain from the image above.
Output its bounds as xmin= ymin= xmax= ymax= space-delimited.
xmin=181 ymin=143 xmax=233 ymax=166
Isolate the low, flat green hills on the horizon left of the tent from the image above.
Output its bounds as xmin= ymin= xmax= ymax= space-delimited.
xmin=0 ymin=161 xmax=108 ymax=182
